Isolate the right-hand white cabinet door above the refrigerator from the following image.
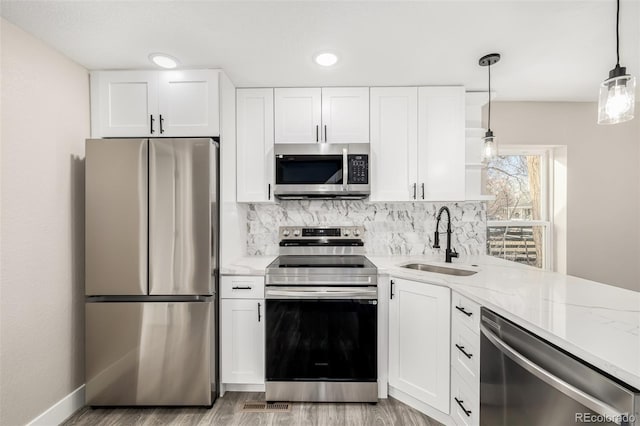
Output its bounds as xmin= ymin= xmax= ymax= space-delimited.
xmin=158 ymin=70 xmax=220 ymax=136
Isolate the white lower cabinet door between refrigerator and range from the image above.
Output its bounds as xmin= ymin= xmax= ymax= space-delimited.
xmin=220 ymin=299 xmax=264 ymax=384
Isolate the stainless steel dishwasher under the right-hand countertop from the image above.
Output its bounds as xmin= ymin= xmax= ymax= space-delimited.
xmin=480 ymin=308 xmax=640 ymax=426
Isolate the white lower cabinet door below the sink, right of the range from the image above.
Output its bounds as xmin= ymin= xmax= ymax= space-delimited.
xmin=389 ymin=278 xmax=451 ymax=414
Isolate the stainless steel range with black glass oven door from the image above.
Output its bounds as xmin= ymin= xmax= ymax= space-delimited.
xmin=265 ymin=227 xmax=378 ymax=402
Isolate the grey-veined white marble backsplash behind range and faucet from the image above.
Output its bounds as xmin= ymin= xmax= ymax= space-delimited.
xmin=247 ymin=200 xmax=487 ymax=256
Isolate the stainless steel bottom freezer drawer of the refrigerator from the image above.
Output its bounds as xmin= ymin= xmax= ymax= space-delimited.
xmin=85 ymin=298 xmax=214 ymax=406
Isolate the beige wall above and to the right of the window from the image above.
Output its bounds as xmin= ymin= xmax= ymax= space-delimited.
xmin=491 ymin=101 xmax=640 ymax=291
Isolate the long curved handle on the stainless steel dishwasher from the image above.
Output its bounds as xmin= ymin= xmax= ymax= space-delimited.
xmin=480 ymin=324 xmax=628 ymax=424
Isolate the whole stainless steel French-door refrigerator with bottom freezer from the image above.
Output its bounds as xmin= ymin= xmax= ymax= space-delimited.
xmin=85 ymin=139 xmax=219 ymax=406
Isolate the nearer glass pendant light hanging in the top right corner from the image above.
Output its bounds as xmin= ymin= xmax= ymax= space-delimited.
xmin=598 ymin=0 xmax=636 ymax=124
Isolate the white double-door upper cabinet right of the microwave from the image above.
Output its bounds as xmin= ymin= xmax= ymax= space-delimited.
xmin=371 ymin=87 xmax=465 ymax=201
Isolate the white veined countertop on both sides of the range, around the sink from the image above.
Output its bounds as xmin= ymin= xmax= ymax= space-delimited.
xmin=221 ymin=256 xmax=640 ymax=389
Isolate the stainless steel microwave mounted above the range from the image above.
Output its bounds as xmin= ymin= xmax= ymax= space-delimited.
xmin=273 ymin=143 xmax=371 ymax=200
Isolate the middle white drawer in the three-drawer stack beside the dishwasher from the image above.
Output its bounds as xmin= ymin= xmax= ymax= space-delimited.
xmin=451 ymin=321 xmax=480 ymax=393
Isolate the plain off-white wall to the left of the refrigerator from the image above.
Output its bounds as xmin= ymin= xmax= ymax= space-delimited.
xmin=0 ymin=19 xmax=89 ymax=425
